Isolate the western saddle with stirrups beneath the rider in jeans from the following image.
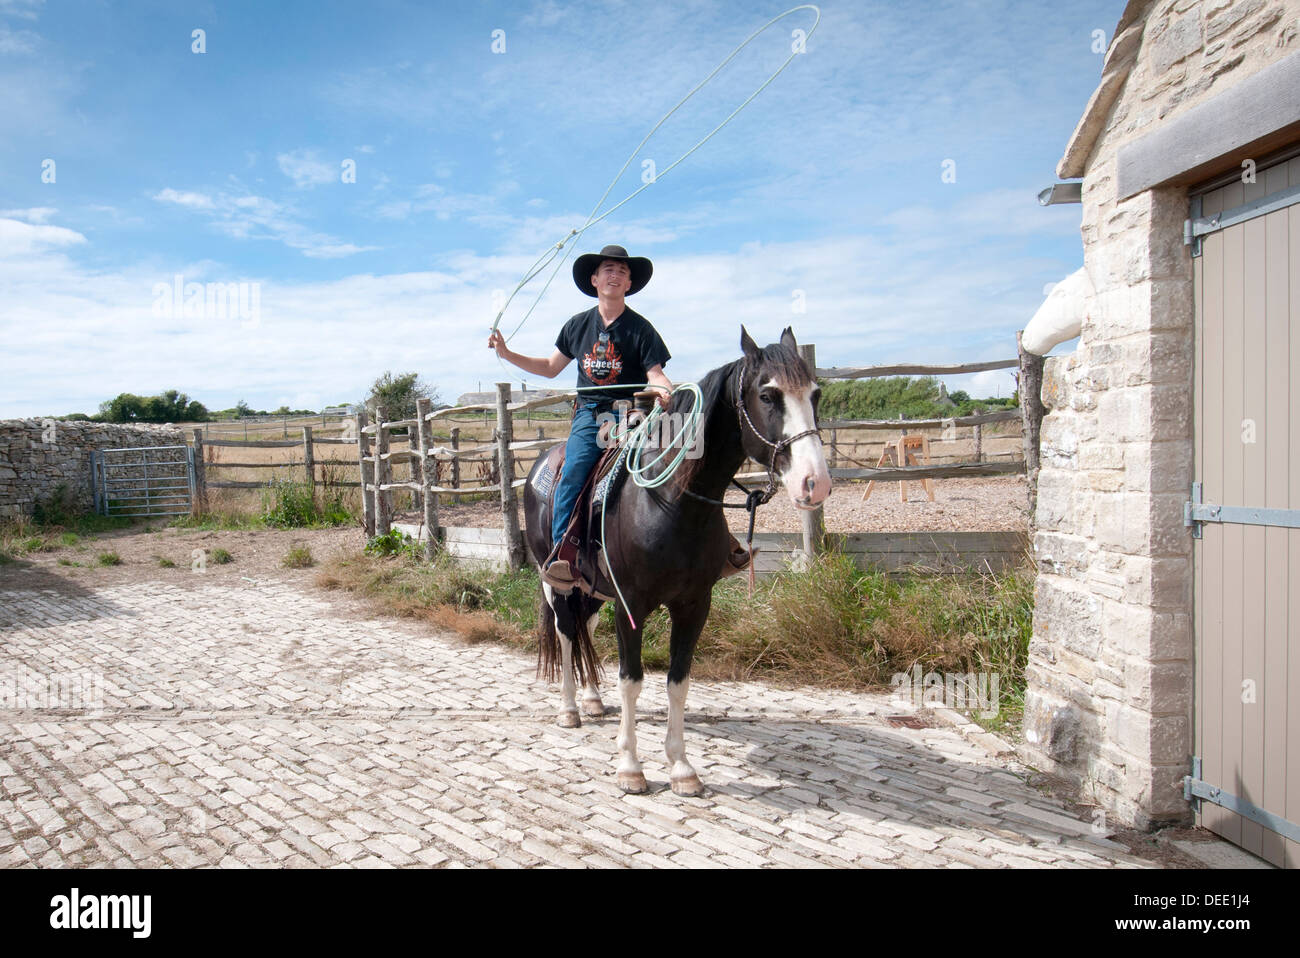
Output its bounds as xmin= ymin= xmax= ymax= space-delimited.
xmin=534 ymin=393 xmax=754 ymax=602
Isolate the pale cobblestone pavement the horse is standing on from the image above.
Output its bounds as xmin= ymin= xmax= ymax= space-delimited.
xmin=0 ymin=571 xmax=1151 ymax=867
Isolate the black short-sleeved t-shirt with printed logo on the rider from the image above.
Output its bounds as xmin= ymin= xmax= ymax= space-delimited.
xmin=555 ymin=305 xmax=671 ymax=403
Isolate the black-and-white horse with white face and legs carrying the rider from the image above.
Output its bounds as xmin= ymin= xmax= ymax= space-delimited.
xmin=524 ymin=326 xmax=831 ymax=796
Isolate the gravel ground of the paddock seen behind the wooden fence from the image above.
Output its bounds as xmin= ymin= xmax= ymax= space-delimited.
xmin=423 ymin=476 xmax=1028 ymax=532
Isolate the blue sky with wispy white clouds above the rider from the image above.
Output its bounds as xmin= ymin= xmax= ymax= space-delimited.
xmin=0 ymin=0 xmax=1123 ymax=417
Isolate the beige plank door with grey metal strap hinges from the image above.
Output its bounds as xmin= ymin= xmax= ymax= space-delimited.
xmin=1184 ymin=151 xmax=1300 ymax=867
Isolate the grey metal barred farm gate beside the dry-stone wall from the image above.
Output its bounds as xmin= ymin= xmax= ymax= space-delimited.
xmin=90 ymin=446 xmax=194 ymax=517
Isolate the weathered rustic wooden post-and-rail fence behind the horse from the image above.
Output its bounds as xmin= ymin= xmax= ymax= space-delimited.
xmin=194 ymin=344 xmax=1043 ymax=571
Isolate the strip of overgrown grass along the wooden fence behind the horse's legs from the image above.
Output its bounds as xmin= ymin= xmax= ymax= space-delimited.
xmin=316 ymin=541 xmax=1034 ymax=731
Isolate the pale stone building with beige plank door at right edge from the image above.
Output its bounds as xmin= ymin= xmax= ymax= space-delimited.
xmin=1023 ymin=0 xmax=1300 ymax=866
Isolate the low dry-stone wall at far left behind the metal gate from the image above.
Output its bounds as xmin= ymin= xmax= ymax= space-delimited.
xmin=0 ymin=419 xmax=185 ymax=519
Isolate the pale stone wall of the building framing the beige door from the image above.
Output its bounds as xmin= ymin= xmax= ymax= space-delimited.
xmin=1023 ymin=0 xmax=1300 ymax=827
